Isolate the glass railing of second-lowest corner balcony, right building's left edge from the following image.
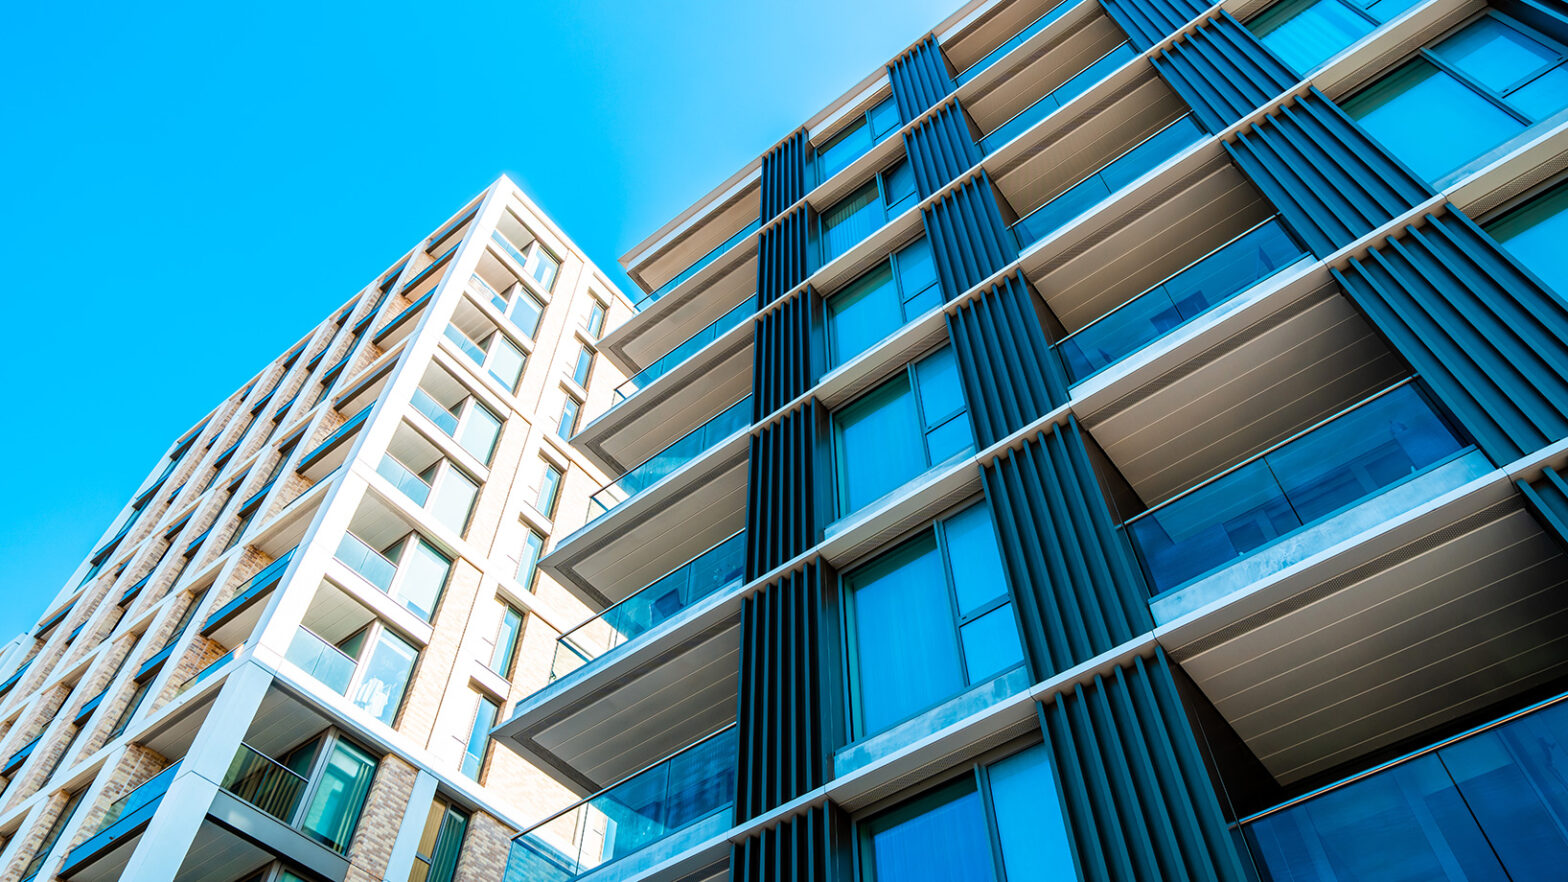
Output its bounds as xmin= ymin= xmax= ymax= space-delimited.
xmin=550 ymin=530 xmax=746 ymax=681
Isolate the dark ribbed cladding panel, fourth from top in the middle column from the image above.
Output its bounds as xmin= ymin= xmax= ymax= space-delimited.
xmin=947 ymin=273 xmax=1068 ymax=447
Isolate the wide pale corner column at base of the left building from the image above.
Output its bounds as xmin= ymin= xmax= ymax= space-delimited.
xmin=121 ymin=662 xmax=273 ymax=882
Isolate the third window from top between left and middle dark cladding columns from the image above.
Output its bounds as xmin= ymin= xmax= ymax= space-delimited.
xmin=828 ymin=237 xmax=942 ymax=364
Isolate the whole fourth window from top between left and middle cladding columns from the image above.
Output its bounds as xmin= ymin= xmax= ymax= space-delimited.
xmin=833 ymin=348 xmax=974 ymax=515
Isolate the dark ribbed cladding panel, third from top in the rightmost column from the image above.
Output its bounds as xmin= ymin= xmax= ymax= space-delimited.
xmin=1225 ymin=86 xmax=1432 ymax=257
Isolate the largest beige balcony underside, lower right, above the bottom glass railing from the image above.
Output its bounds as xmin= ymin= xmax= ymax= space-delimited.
xmin=1160 ymin=472 xmax=1568 ymax=785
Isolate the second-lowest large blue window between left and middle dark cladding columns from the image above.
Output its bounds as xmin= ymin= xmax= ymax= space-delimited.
xmin=845 ymin=504 xmax=1024 ymax=736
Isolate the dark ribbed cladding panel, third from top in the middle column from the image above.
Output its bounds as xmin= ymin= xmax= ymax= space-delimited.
xmin=920 ymin=171 xmax=1018 ymax=300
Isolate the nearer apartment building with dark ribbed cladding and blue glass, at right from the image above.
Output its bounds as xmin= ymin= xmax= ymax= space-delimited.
xmin=497 ymin=0 xmax=1568 ymax=882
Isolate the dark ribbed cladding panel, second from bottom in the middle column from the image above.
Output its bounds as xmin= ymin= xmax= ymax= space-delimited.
xmin=980 ymin=417 xmax=1154 ymax=681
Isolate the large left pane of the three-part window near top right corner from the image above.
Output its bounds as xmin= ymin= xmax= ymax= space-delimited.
xmin=1344 ymin=58 xmax=1524 ymax=180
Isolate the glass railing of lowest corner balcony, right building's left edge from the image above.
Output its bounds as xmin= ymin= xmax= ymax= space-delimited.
xmin=503 ymin=725 xmax=735 ymax=882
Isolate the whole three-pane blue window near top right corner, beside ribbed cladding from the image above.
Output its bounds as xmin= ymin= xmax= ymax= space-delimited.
xmin=1344 ymin=14 xmax=1568 ymax=182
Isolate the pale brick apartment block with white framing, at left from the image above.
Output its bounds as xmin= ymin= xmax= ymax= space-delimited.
xmin=0 ymin=177 xmax=630 ymax=882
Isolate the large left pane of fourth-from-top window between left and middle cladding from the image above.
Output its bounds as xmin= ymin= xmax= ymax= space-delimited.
xmin=834 ymin=373 xmax=925 ymax=515
